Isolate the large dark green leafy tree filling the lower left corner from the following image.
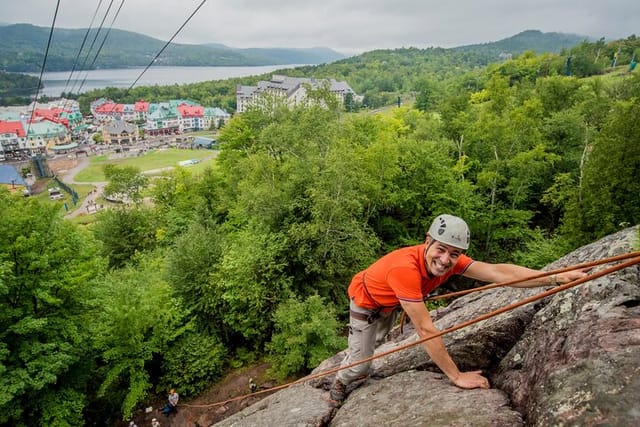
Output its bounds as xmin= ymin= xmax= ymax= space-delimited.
xmin=0 ymin=189 xmax=104 ymax=426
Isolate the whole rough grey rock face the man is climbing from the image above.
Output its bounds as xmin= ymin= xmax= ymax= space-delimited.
xmin=216 ymin=227 xmax=640 ymax=426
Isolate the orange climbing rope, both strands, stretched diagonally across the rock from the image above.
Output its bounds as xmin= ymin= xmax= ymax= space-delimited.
xmin=182 ymin=252 xmax=640 ymax=408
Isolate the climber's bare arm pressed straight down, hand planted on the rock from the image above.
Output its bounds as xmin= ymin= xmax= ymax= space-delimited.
xmin=400 ymin=301 xmax=489 ymax=388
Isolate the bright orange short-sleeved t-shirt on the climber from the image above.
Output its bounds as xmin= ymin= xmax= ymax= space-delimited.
xmin=348 ymin=243 xmax=473 ymax=309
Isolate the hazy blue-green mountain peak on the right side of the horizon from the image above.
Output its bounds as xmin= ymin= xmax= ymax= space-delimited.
xmin=451 ymin=30 xmax=590 ymax=58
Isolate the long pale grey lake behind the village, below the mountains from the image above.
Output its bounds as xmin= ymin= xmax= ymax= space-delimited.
xmin=35 ymin=64 xmax=304 ymax=97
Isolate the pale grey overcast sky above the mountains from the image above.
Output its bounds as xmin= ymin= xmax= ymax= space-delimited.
xmin=0 ymin=0 xmax=640 ymax=54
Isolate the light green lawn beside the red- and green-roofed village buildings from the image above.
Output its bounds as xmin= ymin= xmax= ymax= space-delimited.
xmin=74 ymin=148 xmax=217 ymax=182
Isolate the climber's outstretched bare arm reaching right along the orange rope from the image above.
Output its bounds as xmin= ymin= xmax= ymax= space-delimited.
xmin=462 ymin=261 xmax=588 ymax=288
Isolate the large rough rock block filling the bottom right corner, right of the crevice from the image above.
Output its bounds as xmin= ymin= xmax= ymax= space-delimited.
xmin=495 ymin=230 xmax=640 ymax=426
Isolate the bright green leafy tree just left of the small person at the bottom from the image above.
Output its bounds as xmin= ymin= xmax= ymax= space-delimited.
xmin=92 ymin=253 xmax=190 ymax=419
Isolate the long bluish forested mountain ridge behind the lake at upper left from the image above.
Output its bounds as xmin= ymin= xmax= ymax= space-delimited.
xmin=0 ymin=24 xmax=345 ymax=72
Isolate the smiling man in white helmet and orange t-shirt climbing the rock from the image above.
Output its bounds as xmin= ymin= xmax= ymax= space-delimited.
xmin=329 ymin=214 xmax=587 ymax=404
